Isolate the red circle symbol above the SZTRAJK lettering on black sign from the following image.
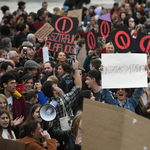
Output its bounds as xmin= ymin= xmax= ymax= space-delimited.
xmin=55 ymin=17 xmax=73 ymax=34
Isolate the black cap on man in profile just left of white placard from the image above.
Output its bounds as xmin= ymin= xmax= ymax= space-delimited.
xmin=88 ymin=70 xmax=101 ymax=86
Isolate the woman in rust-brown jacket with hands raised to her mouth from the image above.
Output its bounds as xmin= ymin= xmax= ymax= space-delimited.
xmin=17 ymin=121 xmax=57 ymax=150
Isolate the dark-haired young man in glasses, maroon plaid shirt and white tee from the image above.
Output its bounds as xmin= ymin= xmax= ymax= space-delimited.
xmin=0 ymin=73 xmax=27 ymax=137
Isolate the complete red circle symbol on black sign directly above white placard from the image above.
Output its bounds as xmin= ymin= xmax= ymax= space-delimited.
xmin=115 ymin=31 xmax=130 ymax=50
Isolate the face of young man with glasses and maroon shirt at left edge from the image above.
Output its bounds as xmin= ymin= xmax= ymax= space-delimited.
xmin=3 ymin=80 xmax=16 ymax=93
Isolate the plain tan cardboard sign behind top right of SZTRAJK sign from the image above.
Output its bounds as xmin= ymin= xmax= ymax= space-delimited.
xmin=68 ymin=9 xmax=82 ymax=26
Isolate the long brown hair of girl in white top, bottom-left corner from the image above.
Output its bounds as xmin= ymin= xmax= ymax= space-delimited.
xmin=0 ymin=109 xmax=14 ymax=139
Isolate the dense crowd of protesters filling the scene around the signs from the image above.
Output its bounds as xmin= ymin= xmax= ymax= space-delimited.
xmin=0 ymin=0 xmax=150 ymax=150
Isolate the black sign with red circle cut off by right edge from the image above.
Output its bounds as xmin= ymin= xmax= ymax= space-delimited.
xmin=135 ymin=32 xmax=150 ymax=53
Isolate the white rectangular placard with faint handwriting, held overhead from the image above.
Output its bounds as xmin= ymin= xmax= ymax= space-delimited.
xmin=102 ymin=54 xmax=147 ymax=89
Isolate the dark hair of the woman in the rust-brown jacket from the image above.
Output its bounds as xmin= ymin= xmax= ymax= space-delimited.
xmin=19 ymin=120 xmax=39 ymax=138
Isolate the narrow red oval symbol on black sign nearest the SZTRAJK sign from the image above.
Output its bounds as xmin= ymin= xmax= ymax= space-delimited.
xmin=87 ymin=31 xmax=96 ymax=49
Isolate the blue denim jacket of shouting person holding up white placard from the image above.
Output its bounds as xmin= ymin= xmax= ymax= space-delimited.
xmin=102 ymin=88 xmax=143 ymax=112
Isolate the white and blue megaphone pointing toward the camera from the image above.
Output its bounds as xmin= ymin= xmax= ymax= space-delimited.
xmin=39 ymin=101 xmax=58 ymax=121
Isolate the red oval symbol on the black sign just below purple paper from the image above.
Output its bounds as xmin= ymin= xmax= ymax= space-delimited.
xmin=100 ymin=21 xmax=110 ymax=38
